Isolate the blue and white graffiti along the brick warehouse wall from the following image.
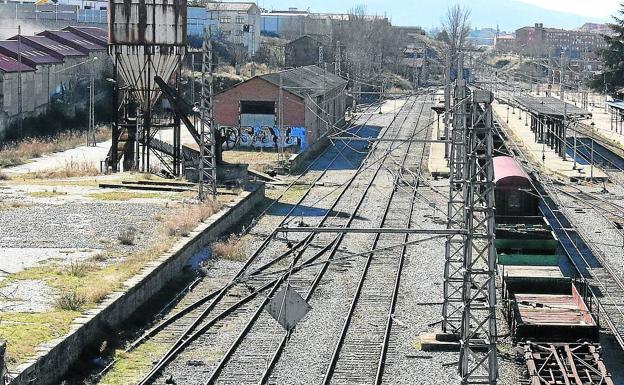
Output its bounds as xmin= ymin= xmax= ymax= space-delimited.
xmin=239 ymin=126 xmax=307 ymax=150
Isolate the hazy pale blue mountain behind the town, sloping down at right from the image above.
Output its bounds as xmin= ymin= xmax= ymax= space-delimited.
xmin=259 ymin=0 xmax=609 ymax=31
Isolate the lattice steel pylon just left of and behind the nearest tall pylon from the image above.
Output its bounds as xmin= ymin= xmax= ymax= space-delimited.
xmin=442 ymin=80 xmax=467 ymax=335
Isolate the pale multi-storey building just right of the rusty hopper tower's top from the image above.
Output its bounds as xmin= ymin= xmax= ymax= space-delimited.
xmin=206 ymin=1 xmax=260 ymax=56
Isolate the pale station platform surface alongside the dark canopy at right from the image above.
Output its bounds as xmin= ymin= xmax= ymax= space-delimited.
xmin=492 ymin=102 xmax=608 ymax=181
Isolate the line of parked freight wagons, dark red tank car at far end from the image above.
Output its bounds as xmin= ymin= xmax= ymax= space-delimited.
xmin=494 ymin=156 xmax=613 ymax=385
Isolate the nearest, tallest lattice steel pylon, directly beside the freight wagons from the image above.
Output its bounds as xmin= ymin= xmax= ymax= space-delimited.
xmin=459 ymin=90 xmax=498 ymax=385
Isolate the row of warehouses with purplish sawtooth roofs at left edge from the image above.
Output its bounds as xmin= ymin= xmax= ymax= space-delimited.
xmin=0 ymin=27 xmax=110 ymax=140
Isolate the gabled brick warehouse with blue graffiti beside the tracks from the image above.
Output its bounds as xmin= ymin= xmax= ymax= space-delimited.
xmin=214 ymin=65 xmax=347 ymax=150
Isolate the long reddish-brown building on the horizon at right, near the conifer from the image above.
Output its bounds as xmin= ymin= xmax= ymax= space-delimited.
xmin=516 ymin=23 xmax=606 ymax=59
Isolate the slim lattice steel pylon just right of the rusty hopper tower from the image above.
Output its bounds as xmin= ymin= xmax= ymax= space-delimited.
xmin=198 ymin=27 xmax=217 ymax=201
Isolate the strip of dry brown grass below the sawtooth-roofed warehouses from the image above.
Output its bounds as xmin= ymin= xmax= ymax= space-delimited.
xmin=0 ymin=128 xmax=111 ymax=167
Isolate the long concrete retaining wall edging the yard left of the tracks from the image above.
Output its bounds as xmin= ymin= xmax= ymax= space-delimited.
xmin=9 ymin=185 xmax=264 ymax=385
